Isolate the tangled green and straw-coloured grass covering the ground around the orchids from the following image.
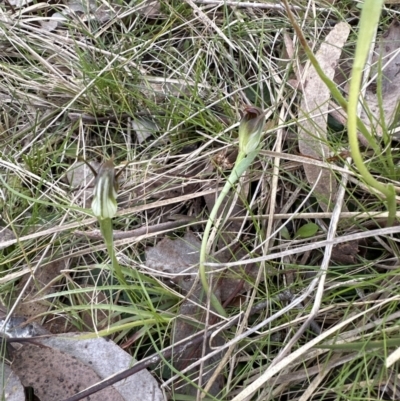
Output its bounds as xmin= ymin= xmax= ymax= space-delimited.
xmin=0 ymin=1 xmax=399 ymax=400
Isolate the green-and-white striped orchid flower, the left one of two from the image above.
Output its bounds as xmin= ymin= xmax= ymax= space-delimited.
xmin=92 ymin=159 xmax=118 ymax=219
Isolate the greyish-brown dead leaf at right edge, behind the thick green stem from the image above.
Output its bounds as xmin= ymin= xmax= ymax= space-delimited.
xmin=361 ymin=19 xmax=400 ymax=135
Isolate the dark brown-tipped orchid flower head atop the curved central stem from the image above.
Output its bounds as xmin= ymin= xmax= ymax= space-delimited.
xmin=239 ymin=106 xmax=265 ymax=155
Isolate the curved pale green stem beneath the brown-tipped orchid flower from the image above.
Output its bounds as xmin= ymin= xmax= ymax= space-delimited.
xmin=199 ymin=150 xmax=258 ymax=316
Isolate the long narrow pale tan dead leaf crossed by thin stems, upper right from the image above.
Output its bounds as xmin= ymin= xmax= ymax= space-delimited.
xmin=299 ymin=22 xmax=350 ymax=211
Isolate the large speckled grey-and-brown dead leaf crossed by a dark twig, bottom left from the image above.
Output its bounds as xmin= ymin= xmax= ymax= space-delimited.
xmin=11 ymin=334 xmax=164 ymax=401
